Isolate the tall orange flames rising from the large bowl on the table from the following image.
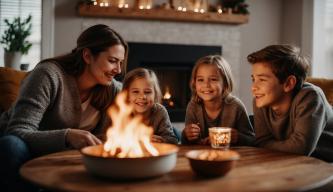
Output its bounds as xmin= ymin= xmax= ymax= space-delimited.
xmin=103 ymin=92 xmax=159 ymax=158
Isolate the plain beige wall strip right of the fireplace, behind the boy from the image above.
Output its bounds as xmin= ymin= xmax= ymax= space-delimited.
xmin=239 ymin=0 xmax=283 ymax=113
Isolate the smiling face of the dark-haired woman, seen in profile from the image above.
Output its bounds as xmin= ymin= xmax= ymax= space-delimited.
xmin=83 ymin=45 xmax=125 ymax=85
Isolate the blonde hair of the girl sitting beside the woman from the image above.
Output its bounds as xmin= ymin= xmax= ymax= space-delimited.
xmin=123 ymin=68 xmax=162 ymax=103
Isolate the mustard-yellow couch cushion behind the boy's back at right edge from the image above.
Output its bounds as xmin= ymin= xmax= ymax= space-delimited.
xmin=306 ymin=77 xmax=333 ymax=105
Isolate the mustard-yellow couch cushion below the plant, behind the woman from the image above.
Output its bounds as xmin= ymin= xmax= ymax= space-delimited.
xmin=0 ymin=67 xmax=28 ymax=111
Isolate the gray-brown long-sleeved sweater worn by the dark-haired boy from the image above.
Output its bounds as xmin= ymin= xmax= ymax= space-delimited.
xmin=253 ymin=83 xmax=333 ymax=161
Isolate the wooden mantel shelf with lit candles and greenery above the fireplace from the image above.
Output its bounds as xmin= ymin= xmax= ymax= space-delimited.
xmin=78 ymin=0 xmax=248 ymax=24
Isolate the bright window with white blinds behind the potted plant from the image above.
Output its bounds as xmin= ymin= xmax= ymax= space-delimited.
xmin=0 ymin=0 xmax=42 ymax=70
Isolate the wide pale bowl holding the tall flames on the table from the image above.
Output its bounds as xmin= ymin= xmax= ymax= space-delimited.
xmin=81 ymin=143 xmax=178 ymax=180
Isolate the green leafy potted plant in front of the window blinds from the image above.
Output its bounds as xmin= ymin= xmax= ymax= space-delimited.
xmin=0 ymin=15 xmax=32 ymax=70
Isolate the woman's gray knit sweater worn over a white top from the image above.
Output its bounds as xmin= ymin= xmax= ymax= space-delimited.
xmin=0 ymin=62 xmax=121 ymax=155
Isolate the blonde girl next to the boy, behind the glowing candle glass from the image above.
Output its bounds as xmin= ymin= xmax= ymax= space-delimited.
xmin=182 ymin=55 xmax=255 ymax=145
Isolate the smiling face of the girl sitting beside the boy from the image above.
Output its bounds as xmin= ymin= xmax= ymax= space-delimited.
xmin=195 ymin=64 xmax=223 ymax=102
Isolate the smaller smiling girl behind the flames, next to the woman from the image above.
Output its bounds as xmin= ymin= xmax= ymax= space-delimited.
xmin=123 ymin=68 xmax=178 ymax=144
